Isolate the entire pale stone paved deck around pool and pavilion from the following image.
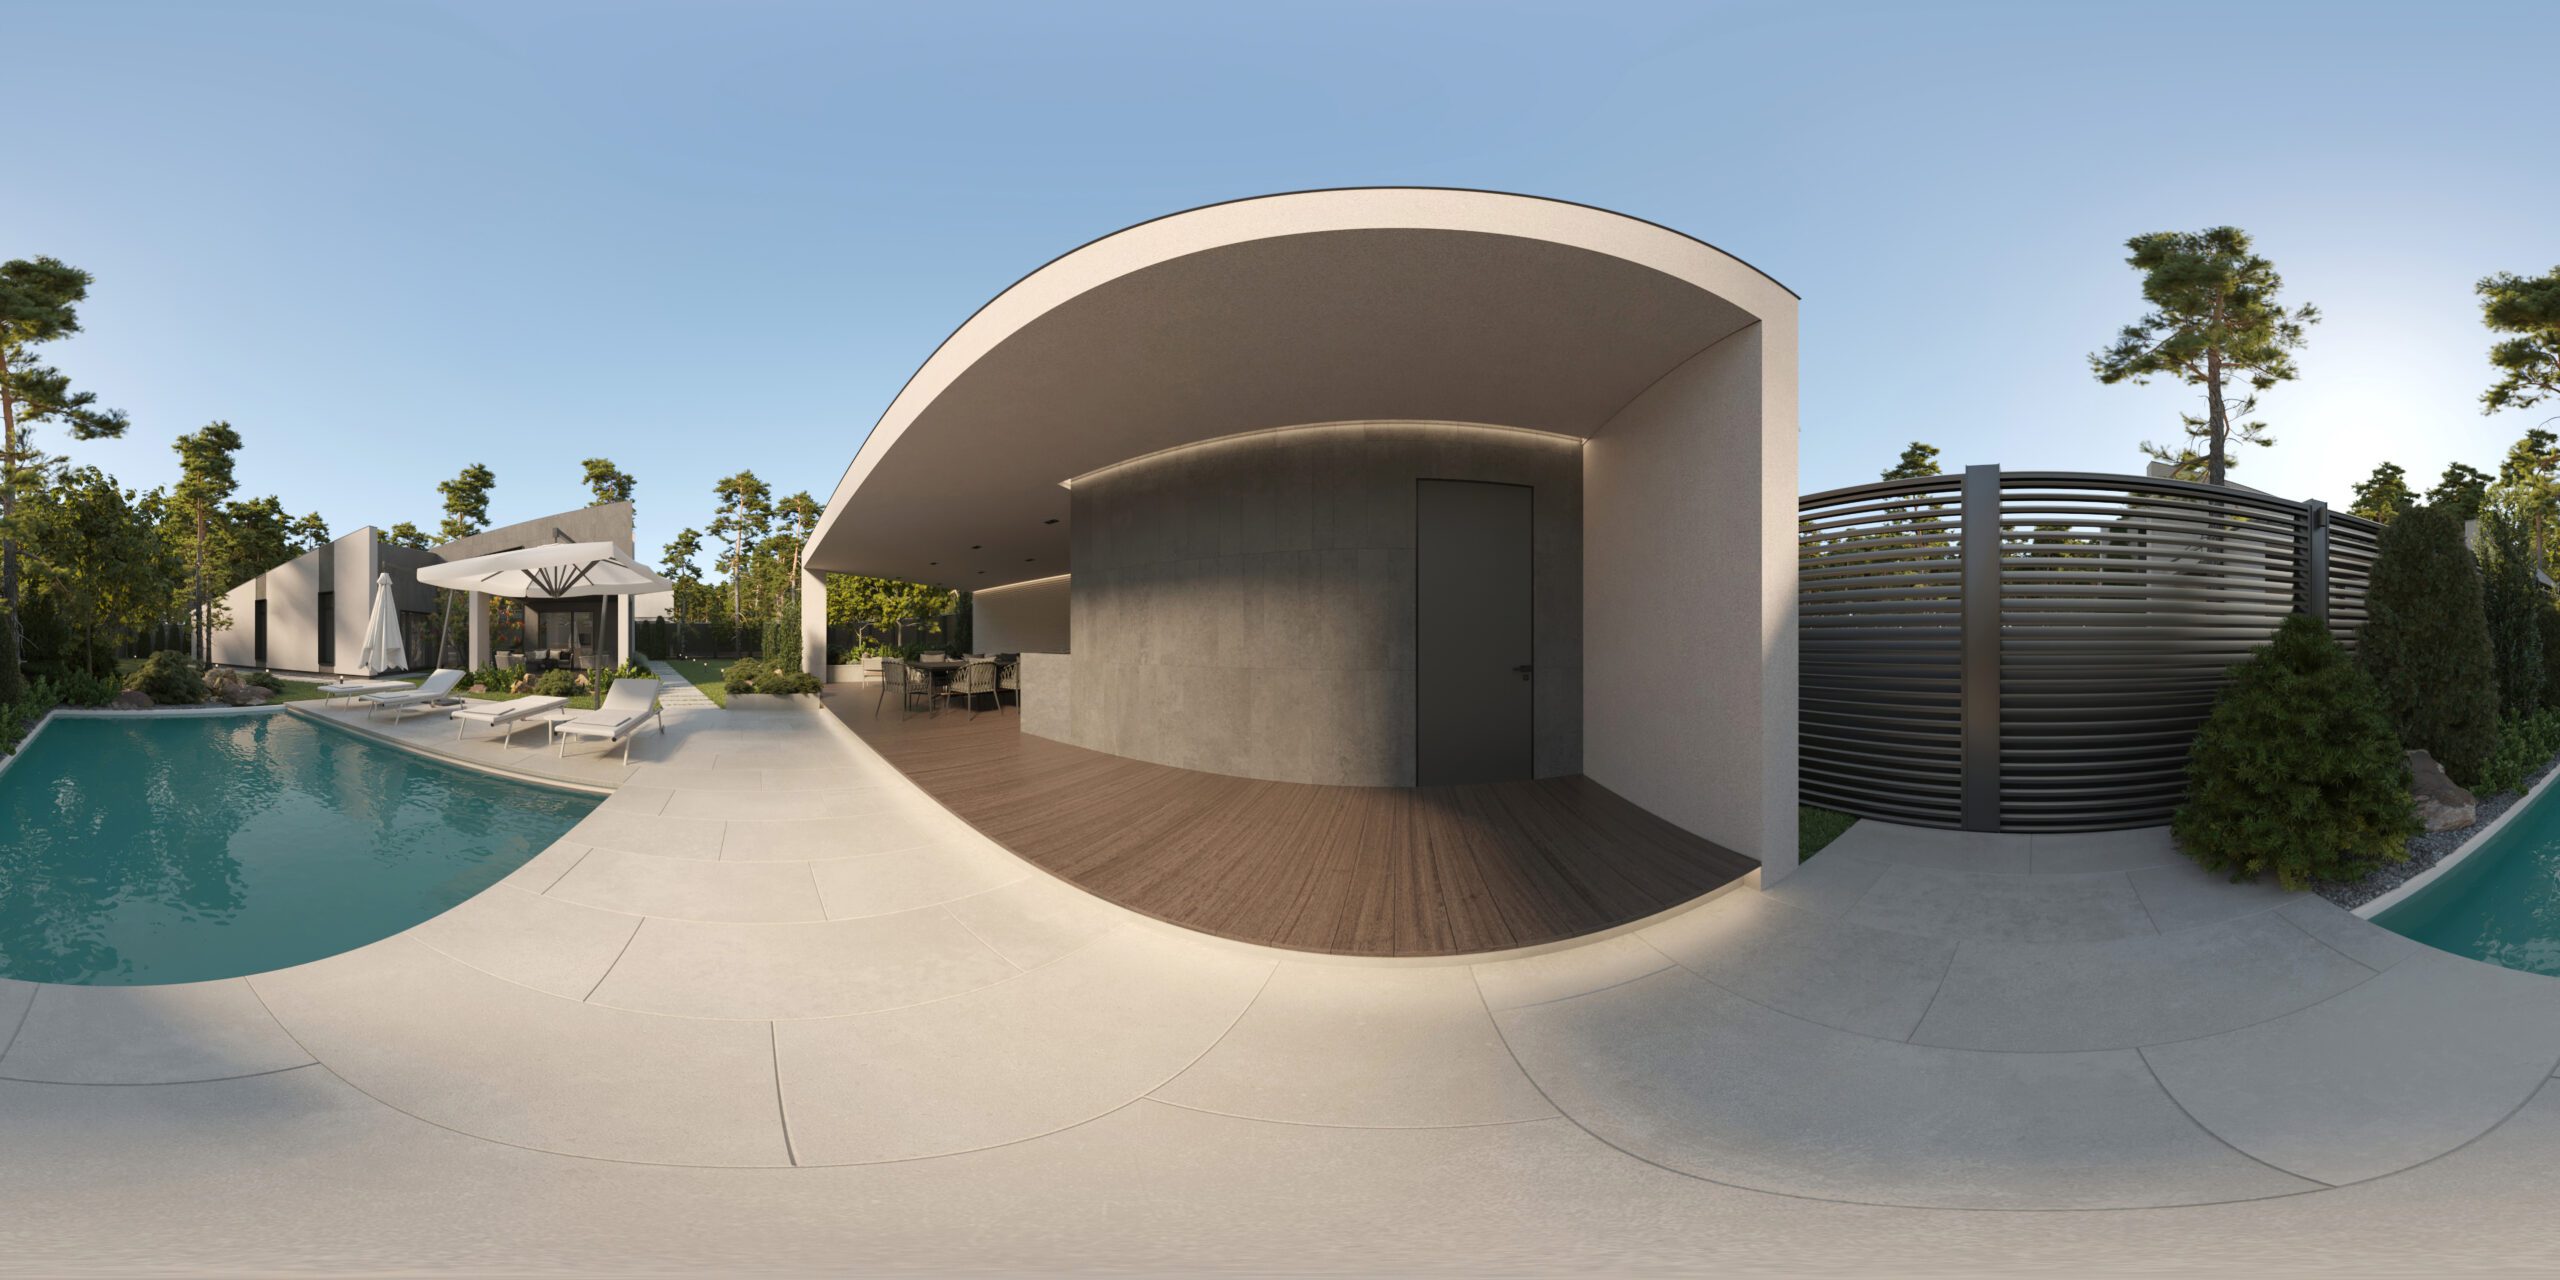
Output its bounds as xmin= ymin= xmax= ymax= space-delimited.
xmin=0 ymin=709 xmax=2560 ymax=1275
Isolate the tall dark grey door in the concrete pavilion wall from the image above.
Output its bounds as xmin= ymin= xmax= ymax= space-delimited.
xmin=1413 ymin=481 xmax=1536 ymax=786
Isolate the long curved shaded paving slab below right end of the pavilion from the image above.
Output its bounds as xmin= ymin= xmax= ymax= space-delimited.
xmin=1498 ymin=970 xmax=2312 ymax=1208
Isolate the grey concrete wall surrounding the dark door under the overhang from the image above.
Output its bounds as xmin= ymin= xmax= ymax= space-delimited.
xmin=1044 ymin=422 xmax=1582 ymax=786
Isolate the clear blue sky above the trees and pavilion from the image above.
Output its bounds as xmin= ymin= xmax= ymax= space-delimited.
xmin=20 ymin=0 xmax=2560 ymax=556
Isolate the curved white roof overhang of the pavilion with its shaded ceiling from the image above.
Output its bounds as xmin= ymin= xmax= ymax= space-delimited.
xmin=806 ymin=187 xmax=1795 ymax=589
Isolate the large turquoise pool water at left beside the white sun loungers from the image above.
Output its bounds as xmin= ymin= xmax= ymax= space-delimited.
xmin=0 ymin=714 xmax=602 ymax=986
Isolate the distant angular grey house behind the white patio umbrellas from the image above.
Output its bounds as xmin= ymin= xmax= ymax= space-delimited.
xmin=212 ymin=502 xmax=666 ymax=676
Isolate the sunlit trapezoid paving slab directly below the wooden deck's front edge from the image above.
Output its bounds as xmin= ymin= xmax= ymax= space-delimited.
xmin=1155 ymin=963 xmax=1556 ymax=1126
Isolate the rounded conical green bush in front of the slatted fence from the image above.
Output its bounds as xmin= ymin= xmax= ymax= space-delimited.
xmin=2171 ymin=611 xmax=2419 ymax=888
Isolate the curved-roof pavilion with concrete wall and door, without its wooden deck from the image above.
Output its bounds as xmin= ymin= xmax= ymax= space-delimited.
xmin=804 ymin=189 xmax=1797 ymax=878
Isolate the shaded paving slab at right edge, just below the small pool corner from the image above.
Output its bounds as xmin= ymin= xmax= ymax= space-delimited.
xmin=2143 ymin=952 xmax=2560 ymax=1185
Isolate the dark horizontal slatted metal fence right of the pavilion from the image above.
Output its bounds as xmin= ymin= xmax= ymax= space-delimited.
xmin=1797 ymin=466 xmax=2381 ymax=832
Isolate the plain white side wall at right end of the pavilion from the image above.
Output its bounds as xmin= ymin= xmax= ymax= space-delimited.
xmin=1582 ymin=323 xmax=1795 ymax=883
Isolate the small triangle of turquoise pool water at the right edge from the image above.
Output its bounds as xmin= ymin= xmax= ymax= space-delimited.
xmin=2373 ymin=773 xmax=2560 ymax=973
